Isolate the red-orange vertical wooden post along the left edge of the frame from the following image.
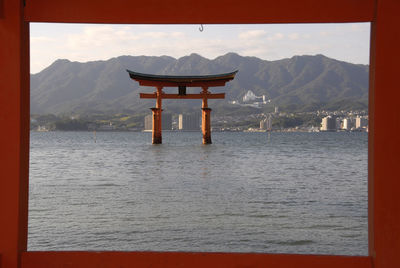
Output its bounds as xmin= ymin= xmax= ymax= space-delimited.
xmin=0 ymin=0 xmax=30 ymax=268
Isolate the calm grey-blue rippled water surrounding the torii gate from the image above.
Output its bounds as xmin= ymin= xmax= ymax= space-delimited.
xmin=28 ymin=132 xmax=368 ymax=255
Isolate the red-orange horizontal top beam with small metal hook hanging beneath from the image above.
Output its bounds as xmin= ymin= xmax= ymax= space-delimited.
xmin=25 ymin=0 xmax=376 ymax=23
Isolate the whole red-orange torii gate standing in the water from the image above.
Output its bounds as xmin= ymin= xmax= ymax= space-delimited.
xmin=127 ymin=70 xmax=238 ymax=144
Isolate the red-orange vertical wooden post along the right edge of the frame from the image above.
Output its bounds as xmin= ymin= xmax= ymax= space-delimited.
xmin=368 ymin=0 xmax=400 ymax=268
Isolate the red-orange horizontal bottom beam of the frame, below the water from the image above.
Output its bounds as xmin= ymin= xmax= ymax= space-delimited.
xmin=22 ymin=252 xmax=372 ymax=268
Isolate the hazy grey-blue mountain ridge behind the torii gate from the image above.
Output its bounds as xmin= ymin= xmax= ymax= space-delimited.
xmin=31 ymin=53 xmax=368 ymax=114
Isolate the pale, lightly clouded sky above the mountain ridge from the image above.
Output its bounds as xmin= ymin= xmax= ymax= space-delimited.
xmin=30 ymin=23 xmax=370 ymax=73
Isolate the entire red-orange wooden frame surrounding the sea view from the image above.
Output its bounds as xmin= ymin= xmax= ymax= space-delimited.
xmin=0 ymin=0 xmax=400 ymax=268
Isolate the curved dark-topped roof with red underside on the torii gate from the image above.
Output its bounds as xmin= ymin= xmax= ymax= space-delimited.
xmin=126 ymin=70 xmax=238 ymax=87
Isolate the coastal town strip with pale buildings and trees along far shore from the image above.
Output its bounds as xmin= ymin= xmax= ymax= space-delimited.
xmin=31 ymin=107 xmax=368 ymax=132
